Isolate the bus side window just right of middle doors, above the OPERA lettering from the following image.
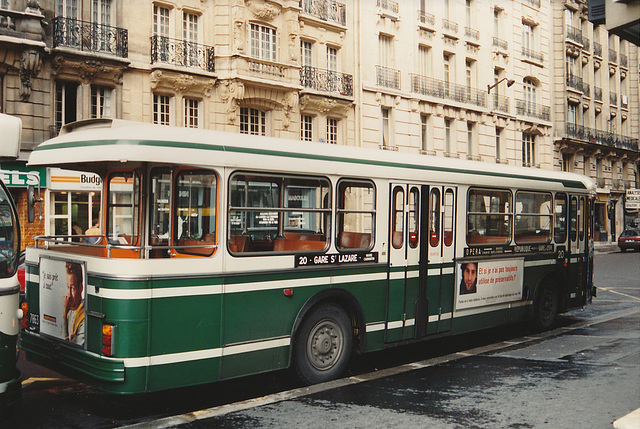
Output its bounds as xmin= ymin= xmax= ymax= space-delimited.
xmin=467 ymin=189 xmax=513 ymax=246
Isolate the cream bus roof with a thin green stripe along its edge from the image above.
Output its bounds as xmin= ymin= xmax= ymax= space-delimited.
xmin=29 ymin=119 xmax=595 ymax=192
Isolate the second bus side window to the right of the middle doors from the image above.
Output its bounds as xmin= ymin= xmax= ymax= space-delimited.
xmin=515 ymin=192 xmax=552 ymax=244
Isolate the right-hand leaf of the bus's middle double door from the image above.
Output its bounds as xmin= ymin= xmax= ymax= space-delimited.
xmin=418 ymin=186 xmax=457 ymax=336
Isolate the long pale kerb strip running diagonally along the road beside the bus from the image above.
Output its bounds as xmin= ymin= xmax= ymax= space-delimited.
xmin=121 ymin=308 xmax=640 ymax=429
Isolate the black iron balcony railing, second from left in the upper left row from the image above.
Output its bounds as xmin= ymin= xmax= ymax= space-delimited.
xmin=151 ymin=36 xmax=215 ymax=72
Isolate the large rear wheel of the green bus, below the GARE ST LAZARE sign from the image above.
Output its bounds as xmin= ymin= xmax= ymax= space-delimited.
xmin=293 ymin=304 xmax=353 ymax=384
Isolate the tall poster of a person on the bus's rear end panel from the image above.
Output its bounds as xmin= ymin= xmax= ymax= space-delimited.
xmin=40 ymin=258 xmax=86 ymax=346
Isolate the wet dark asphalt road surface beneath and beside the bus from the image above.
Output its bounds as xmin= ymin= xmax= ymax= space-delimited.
xmin=7 ymin=249 xmax=640 ymax=428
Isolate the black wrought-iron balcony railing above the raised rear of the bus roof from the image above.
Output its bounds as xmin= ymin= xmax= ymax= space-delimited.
xmin=53 ymin=16 xmax=129 ymax=58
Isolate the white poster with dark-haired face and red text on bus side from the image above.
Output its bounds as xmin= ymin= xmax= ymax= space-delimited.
xmin=456 ymin=259 xmax=524 ymax=310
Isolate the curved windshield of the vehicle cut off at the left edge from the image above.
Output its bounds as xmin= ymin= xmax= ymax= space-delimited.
xmin=0 ymin=184 xmax=20 ymax=277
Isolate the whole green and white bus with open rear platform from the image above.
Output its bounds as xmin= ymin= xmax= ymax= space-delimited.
xmin=21 ymin=119 xmax=595 ymax=393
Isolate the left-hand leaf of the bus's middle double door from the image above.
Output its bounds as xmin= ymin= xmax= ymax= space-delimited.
xmin=385 ymin=184 xmax=420 ymax=343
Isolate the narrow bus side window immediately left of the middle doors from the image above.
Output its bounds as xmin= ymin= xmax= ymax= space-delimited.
xmin=336 ymin=180 xmax=376 ymax=250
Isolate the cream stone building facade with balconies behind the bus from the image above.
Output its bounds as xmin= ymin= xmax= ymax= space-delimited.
xmin=0 ymin=0 xmax=639 ymax=247
